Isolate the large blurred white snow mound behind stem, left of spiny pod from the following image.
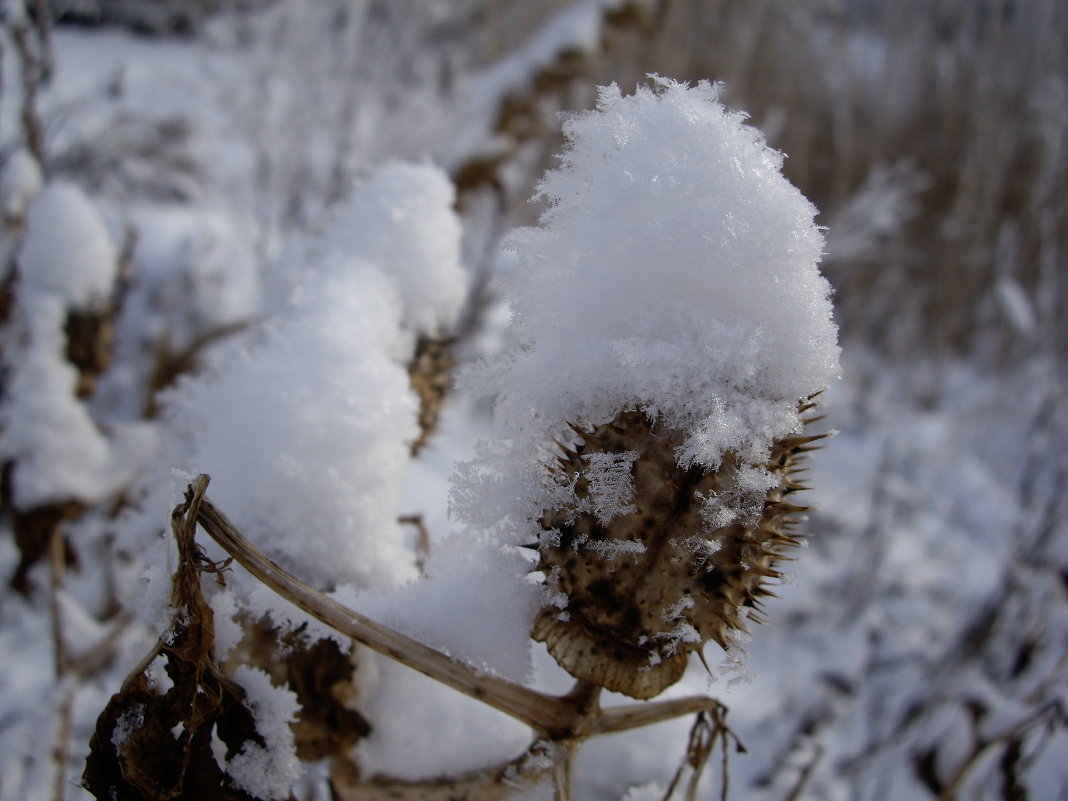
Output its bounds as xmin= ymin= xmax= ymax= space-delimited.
xmin=116 ymin=163 xmax=467 ymax=623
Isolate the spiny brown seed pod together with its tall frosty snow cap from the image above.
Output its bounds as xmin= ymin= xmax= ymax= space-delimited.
xmin=454 ymin=79 xmax=838 ymax=698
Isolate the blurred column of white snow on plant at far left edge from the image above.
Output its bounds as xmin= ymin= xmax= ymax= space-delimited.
xmin=0 ymin=191 xmax=155 ymax=509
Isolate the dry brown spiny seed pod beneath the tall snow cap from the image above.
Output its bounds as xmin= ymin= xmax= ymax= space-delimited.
xmin=534 ymin=404 xmax=817 ymax=698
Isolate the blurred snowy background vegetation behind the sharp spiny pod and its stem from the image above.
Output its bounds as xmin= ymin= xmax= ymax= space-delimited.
xmin=0 ymin=0 xmax=1068 ymax=801
